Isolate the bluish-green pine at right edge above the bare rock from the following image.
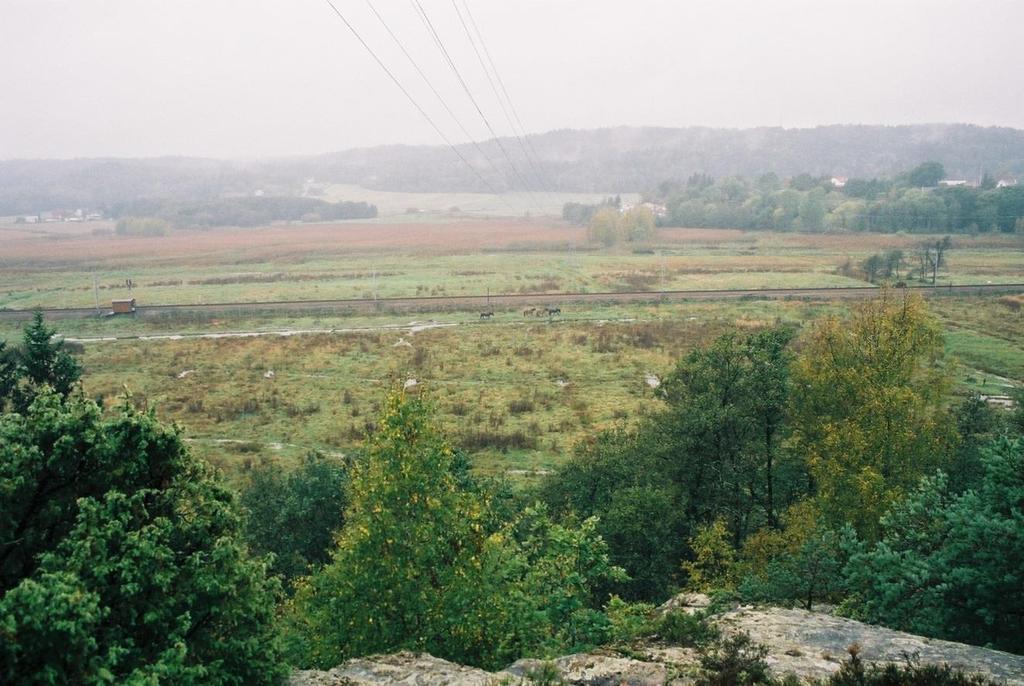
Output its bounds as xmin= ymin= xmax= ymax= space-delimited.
xmin=847 ymin=439 xmax=1024 ymax=652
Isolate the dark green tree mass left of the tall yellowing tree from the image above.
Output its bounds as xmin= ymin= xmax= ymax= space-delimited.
xmin=542 ymin=330 xmax=794 ymax=600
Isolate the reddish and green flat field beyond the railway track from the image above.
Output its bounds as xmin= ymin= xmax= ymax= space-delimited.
xmin=0 ymin=219 xmax=1024 ymax=308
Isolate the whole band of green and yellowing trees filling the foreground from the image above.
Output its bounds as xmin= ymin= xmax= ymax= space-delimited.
xmin=0 ymin=301 xmax=1024 ymax=684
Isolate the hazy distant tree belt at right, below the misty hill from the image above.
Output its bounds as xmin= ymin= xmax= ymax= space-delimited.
xmin=649 ymin=163 xmax=1024 ymax=233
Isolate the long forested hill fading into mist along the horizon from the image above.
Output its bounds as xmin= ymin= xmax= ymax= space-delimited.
xmin=0 ymin=124 xmax=1024 ymax=215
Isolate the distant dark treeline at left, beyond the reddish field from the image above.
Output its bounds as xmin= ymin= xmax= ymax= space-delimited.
xmin=106 ymin=197 xmax=377 ymax=231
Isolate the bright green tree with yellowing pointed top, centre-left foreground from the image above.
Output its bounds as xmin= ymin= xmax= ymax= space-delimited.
xmin=288 ymin=391 xmax=623 ymax=668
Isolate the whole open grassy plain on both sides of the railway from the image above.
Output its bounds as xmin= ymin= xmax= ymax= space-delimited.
xmin=0 ymin=219 xmax=1024 ymax=479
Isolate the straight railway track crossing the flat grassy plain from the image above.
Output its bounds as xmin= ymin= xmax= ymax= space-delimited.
xmin=0 ymin=284 xmax=1024 ymax=321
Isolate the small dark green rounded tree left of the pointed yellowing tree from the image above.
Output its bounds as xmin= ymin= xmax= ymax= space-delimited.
xmin=241 ymin=454 xmax=348 ymax=583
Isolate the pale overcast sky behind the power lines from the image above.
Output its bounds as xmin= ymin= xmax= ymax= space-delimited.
xmin=0 ymin=0 xmax=1024 ymax=159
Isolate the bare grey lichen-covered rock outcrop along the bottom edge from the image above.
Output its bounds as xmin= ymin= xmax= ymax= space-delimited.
xmin=290 ymin=594 xmax=1024 ymax=686
